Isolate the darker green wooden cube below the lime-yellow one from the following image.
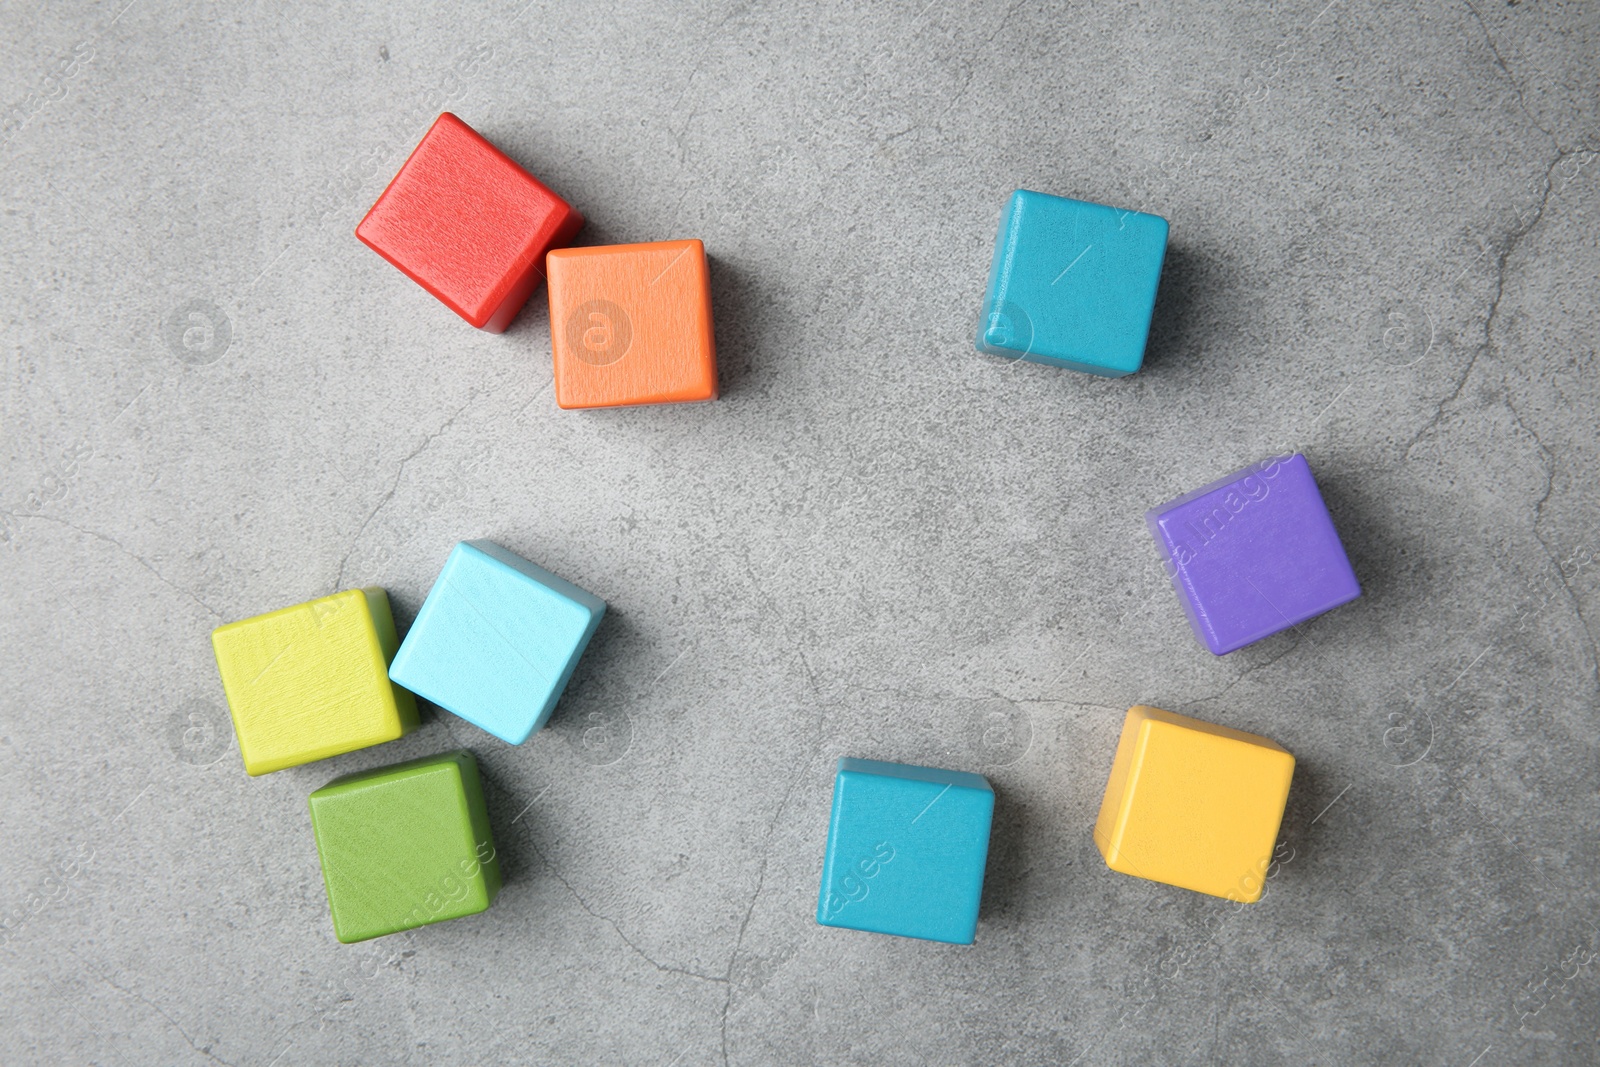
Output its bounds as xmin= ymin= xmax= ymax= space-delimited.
xmin=309 ymin=752 xmax=501 ymax=944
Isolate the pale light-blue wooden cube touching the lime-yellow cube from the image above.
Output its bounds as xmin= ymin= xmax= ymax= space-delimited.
xmin=389 ymin=541 xmax=605 ymax=745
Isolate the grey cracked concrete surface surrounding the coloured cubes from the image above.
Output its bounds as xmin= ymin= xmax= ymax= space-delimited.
xmin=0 ymin=0 xmax=1600 ymax=1067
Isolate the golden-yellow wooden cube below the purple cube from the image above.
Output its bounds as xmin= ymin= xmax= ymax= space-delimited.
xmin=1094 ymin=707 xmax=1294 ymax=904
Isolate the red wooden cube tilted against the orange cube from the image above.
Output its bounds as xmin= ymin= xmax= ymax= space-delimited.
xmin=355 ymin=112 xmax=584 ymax=333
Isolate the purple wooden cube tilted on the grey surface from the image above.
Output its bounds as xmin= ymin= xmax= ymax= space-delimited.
xmin=1144 ymin=453 xmax=1362 ymax=656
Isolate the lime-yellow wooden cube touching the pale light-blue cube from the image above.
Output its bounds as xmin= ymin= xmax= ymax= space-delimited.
xmin=211 ymin=587 xmax=416 ymax=774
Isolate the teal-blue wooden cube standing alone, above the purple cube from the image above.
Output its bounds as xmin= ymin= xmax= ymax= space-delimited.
xmin=978 ymin=189 xmax=1168 ymax=378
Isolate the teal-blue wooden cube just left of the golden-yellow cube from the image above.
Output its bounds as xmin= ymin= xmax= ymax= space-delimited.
xmin=816 ymin=760 xmax=995 ymax=945
